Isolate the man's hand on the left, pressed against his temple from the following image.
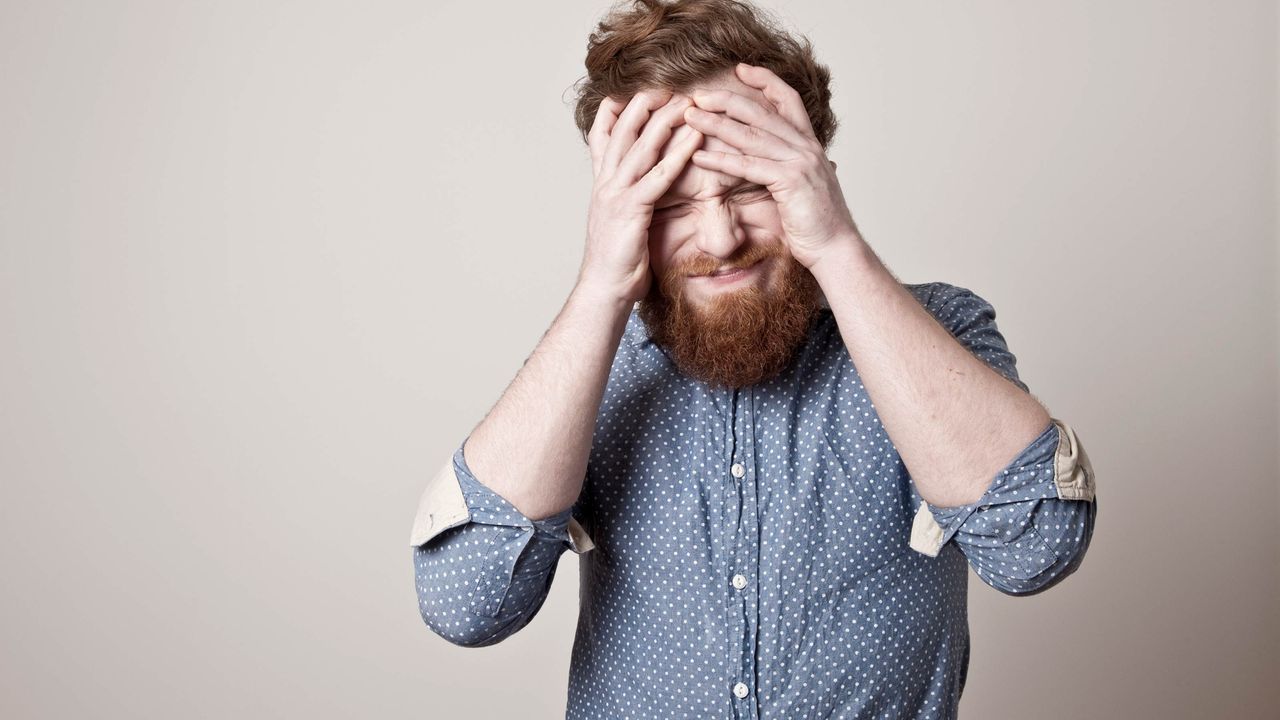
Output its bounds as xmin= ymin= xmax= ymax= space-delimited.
xmin=579 ymin=90 xmax=703 ymax=304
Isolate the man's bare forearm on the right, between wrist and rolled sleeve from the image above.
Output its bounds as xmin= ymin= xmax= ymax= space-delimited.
xmin=810 ymin=236 xmax=1050 ymax=507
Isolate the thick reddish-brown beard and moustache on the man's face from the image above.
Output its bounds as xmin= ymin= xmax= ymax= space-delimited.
xmin=639 ymin=239 xmax=822 ymax=388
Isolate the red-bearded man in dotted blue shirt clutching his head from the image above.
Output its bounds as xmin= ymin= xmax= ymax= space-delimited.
xmin=411 ymin=0 xmax=1097 ymax=719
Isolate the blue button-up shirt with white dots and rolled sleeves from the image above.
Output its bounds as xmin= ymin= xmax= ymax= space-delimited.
xmin=413 ymin=283 xmax=1097 ymax=720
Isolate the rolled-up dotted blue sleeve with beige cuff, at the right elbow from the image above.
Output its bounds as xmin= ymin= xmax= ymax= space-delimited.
xmin=910 ymin=418 xmax=1097 ymax=596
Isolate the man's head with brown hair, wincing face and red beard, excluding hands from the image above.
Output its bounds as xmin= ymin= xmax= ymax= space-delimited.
xmin=576 ymin=0 xmax=836 ymax=387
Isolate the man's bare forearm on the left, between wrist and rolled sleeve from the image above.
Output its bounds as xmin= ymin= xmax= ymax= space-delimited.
xmin=463 ymin=282 xmax=631 ymax=520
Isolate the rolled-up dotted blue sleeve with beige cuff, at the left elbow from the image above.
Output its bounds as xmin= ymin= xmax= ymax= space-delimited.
xmin=410 ymin=441 xmax=594 ymax=647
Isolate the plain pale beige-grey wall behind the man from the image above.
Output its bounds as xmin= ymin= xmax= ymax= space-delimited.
xmin=0 ymin=0 xmax=1280 ymax=719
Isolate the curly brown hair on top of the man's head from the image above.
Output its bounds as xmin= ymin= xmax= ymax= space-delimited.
xmin=573 ymin=0 xmax=838 ymax=149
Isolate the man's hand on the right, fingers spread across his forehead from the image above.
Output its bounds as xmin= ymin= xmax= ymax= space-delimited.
xmin=685 ymin=64 xmax=861 ymax=269
